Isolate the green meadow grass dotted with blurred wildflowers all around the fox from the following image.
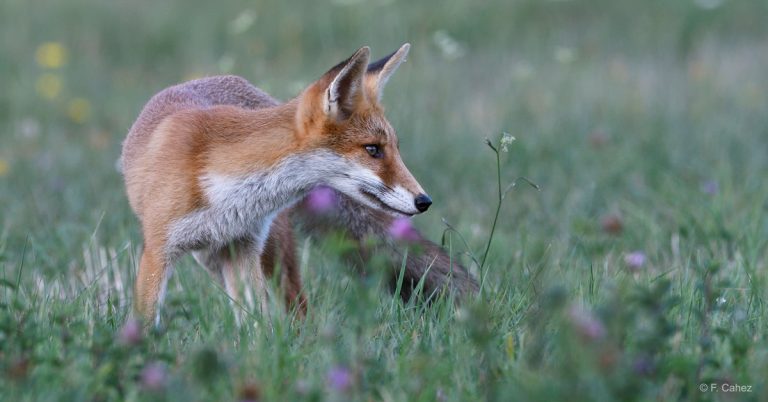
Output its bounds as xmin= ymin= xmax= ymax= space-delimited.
xmin=0 ymin=0 xmax=768 ymax=401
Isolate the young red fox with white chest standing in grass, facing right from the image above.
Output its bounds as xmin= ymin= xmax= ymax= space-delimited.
xmin=121 ymin=44 xmax=477 ymax=323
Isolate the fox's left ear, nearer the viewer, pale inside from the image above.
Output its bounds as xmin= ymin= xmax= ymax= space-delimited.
xmin=323 ymin=46 xmax=371 ymax=120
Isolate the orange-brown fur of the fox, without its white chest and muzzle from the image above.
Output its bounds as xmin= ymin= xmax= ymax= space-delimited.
xmin=122 ymin=45 xmax=431 ymax=326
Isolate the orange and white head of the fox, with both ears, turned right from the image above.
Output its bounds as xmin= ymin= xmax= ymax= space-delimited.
xmin=296 ymin=43 xmax=432 ymax=216
